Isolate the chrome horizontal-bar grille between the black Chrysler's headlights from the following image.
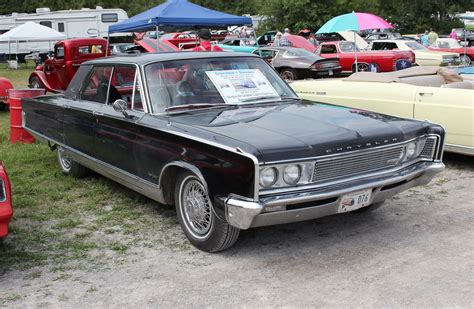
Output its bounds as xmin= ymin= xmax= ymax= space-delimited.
xmin=312 ymin=145 xmax=405 ymax=182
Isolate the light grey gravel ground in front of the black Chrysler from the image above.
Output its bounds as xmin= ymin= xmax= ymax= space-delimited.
xmin=0 ymin=155 xmax=474 ymax=308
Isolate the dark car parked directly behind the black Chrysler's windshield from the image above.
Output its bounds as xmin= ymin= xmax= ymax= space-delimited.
xmin=254 ymin=47 xmax=341 ymax=81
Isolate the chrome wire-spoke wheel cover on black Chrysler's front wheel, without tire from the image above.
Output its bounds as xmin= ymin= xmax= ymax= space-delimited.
xmin=179 ymin=175 xmax=213 ymax=239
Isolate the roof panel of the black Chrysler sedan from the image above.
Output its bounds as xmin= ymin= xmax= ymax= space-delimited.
xmin=84 ymin=51 xmax=259 ymax=65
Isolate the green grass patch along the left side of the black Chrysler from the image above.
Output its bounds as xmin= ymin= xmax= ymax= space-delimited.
xmin=0 ymin=89 xmax=185 ymax=276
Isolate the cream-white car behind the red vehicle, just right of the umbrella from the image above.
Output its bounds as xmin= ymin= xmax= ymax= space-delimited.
xmin=369 ymin=40 xmax=461 ymax=66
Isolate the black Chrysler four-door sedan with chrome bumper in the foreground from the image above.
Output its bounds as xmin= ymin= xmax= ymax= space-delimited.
xmin=23 ymin=52 xmax=444 ymax=252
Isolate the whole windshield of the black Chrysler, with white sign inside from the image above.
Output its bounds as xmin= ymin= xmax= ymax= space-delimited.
xmin=145 ymin=57 xmax=297 ymax=113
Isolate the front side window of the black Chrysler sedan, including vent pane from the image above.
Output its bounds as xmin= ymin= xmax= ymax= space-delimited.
xmin=109 ymin=65 xmax=143 ymax=111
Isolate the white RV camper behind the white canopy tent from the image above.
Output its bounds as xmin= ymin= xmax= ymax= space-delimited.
xmin=0 ymin=6 xmax=128 ymax=54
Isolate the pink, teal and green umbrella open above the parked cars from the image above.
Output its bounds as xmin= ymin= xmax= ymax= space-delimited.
xmin=316 ymin=12 xmax=393 ymax=33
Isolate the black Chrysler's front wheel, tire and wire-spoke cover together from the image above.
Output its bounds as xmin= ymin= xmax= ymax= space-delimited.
xmin=175 ymin=171 xmax=240 ymax=252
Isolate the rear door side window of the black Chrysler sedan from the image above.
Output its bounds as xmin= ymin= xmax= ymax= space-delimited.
xmin=81 ymin=66 xmax=112 ymax=104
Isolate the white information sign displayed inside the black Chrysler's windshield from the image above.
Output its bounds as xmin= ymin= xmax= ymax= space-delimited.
xmin=206 ymin=69 xmax=281 ymax=104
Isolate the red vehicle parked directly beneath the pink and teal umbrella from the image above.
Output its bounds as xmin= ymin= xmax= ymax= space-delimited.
xmin=316 ymin=41 xmax=415 ymax=73
